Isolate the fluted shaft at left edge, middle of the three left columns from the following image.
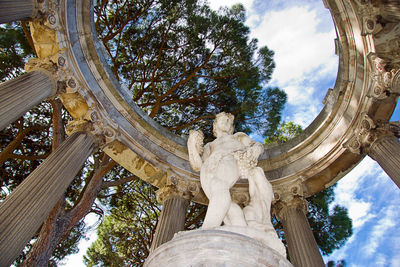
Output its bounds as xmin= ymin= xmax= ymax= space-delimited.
xmin=0 ymin=71 xmax=56 ymax=130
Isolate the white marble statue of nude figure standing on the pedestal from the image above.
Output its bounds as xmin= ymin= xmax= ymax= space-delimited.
xmin=188 ymin=112 xmax=286 ymax=255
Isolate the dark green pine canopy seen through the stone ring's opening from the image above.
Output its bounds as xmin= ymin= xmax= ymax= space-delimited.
xmin=95 ymin=0 xmax=286 ymax=137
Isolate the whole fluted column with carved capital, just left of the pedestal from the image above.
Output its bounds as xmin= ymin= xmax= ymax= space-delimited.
xmin=150 ymin=185 xmax=189 ymax=253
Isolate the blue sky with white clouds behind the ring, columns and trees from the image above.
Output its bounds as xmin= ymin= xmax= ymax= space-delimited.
xmin=65 ymin=0 xmax=400 ymax=267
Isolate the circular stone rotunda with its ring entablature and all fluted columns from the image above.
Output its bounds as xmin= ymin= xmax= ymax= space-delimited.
xmin=0 ymin=0 xmax=400 ymax=267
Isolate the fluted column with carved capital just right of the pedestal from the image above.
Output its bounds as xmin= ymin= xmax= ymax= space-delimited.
xmin=274 ymin=188 xmax=325 ymax=267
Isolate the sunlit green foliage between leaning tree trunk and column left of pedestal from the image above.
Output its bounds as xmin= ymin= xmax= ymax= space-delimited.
xmin=84 ymin=178 xmax=160 ymax=266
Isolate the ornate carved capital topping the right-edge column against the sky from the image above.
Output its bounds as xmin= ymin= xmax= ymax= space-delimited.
xmin=343 ymin=114 xmax=393 ymax=154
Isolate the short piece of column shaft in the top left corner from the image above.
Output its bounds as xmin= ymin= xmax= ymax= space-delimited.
xmin=0 ymin=0 xmax=38 ymax=23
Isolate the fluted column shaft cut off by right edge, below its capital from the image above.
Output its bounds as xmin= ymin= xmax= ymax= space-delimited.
xmin=368 ymin=135 xmax=400 ymax=188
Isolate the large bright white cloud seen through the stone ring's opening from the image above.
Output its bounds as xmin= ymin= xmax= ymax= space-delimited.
xmin=250 ymin=6 xmax=337 ymax=86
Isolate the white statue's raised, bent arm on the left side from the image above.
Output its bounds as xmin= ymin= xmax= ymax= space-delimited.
xmin=187 ymin=130 xmax=204 ymax=172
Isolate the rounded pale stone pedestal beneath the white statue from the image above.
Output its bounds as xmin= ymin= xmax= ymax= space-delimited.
xmin=144 ymin=230 xmax=293 ymax=267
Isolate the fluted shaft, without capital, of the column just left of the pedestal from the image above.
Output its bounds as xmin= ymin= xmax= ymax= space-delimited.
xmin=150 ymin=196 xmax=189 ymax=252
